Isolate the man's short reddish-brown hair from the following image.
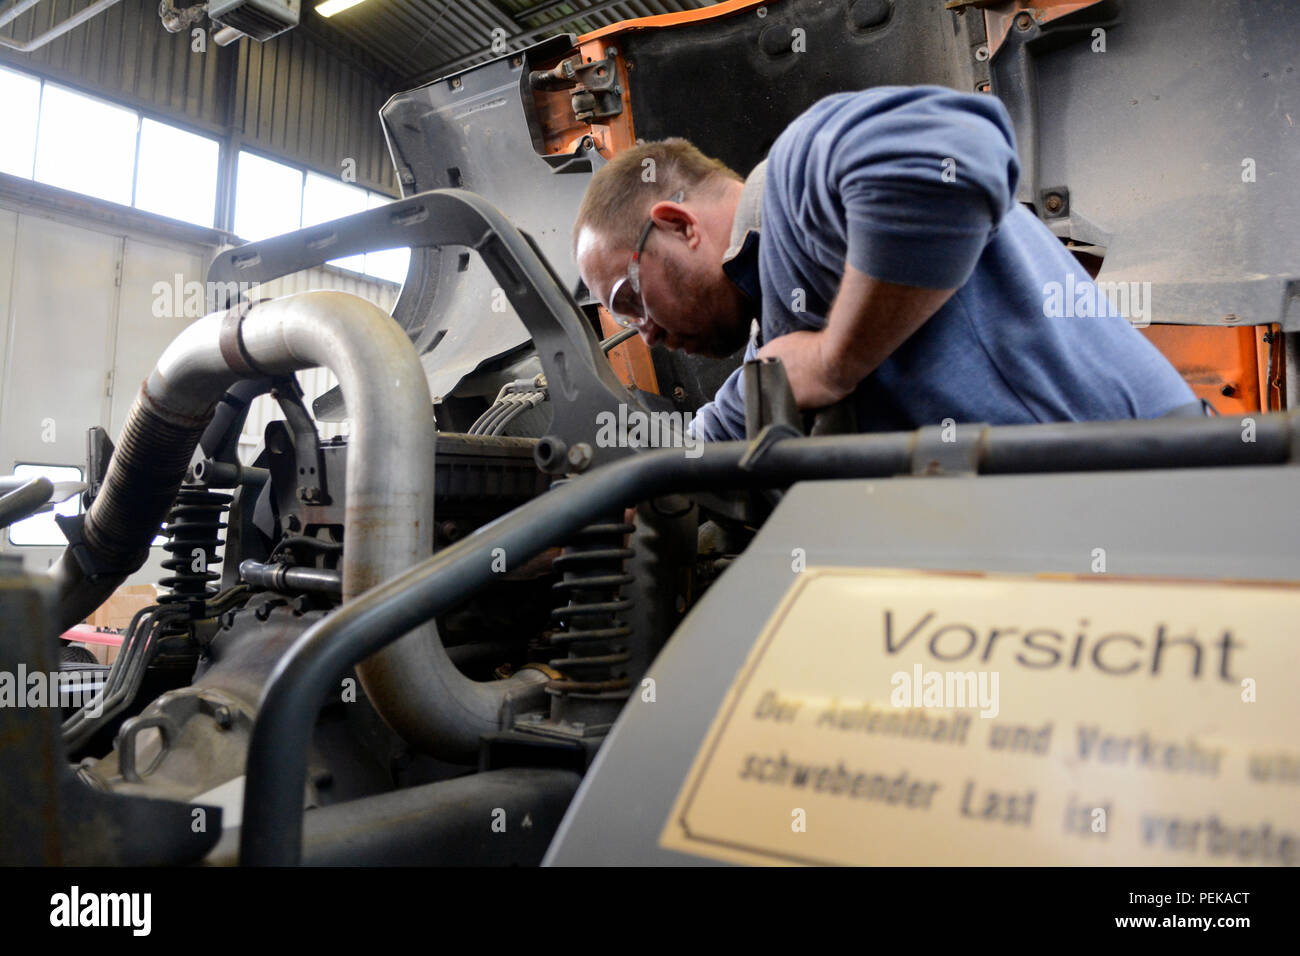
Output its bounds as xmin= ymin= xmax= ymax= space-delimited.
xmin=573 ymin=138 xmax=744 ymax=252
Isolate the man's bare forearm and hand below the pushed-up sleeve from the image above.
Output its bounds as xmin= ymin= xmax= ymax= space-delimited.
xmin=758 ymin=265 xmax=957 ymax=410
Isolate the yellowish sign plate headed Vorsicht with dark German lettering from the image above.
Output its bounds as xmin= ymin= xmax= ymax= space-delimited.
xmin=660 ymin=568 xmax=1300 ymax=865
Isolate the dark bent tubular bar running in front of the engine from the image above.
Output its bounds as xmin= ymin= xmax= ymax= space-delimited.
xmin=239 ymin=412 xmax=1300 ymax=866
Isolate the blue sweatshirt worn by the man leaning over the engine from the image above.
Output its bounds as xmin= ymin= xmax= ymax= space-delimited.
xmin=693 ymin=86 xmax=1195 ymax=441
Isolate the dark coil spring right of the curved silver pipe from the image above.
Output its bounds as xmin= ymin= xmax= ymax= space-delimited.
xmin=546 ymin=516 xmax=634 ymax=697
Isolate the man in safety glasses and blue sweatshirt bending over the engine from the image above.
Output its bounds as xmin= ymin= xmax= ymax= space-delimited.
xmin=573 ymin=86 xmax=1203 ymax=441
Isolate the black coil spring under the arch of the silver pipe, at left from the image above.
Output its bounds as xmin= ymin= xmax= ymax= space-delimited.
xmin=159 ymin=484 xmax=230 ymax=631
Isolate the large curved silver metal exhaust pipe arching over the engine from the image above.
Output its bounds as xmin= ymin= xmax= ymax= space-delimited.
xmin=52 ymin=291 xmax=546 ymax=760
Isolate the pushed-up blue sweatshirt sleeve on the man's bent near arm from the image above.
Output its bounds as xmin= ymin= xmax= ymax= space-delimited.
xmin=805 ymin=86 xmax=1019 ymax=289
